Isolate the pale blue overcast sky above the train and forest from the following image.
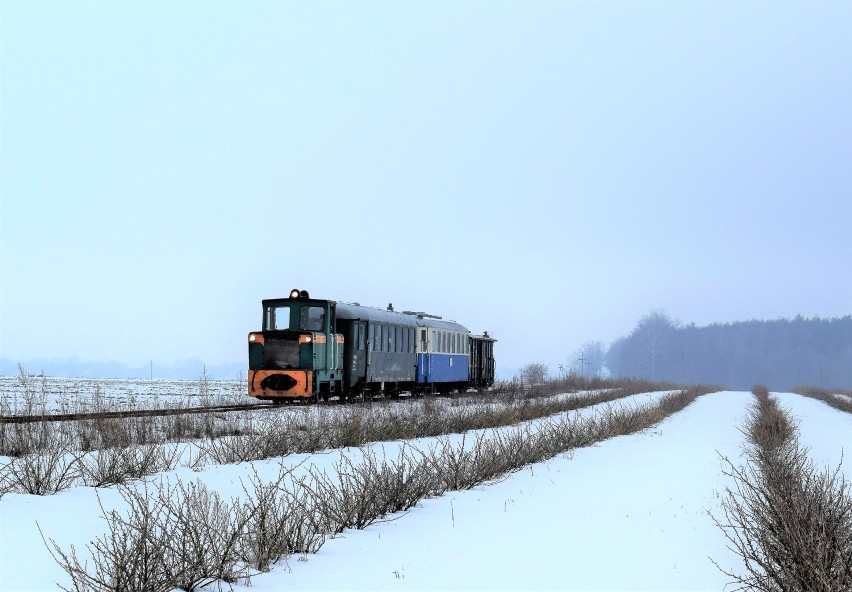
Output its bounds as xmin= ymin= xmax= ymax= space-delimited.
xmin=0 ymin=0 xmax=852 ymax=373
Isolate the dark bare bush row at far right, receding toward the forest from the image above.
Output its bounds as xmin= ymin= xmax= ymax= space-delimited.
xmin=714 ymin=387 xmax=852 ymax=592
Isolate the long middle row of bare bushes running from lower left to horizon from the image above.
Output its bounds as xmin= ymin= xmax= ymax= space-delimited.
xmin=43 ymin=390 xmax=702 ymax=592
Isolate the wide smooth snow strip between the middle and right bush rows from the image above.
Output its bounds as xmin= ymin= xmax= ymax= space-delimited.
xmin=231 ymin=393 xmax=750 ymax=590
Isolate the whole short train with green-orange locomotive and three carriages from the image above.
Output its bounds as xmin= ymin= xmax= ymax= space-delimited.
xmin=248 ymin=290 xmax=496 ymax=403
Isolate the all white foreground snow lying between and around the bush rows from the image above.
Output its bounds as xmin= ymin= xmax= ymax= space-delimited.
xmin=0 ymin=392 xmax=852 ymax=592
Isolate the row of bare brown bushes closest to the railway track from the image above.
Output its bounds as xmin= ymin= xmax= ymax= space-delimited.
xmin=0 ymin=383 xmax=696 ymax=495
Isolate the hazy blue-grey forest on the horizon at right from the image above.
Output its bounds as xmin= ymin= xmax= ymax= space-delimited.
xmin=606 ymin=310 xmax=852 ymax=390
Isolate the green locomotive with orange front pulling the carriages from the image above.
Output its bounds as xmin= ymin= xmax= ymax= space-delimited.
xmin=248 ymin=290 xmax=343 ymax=402
